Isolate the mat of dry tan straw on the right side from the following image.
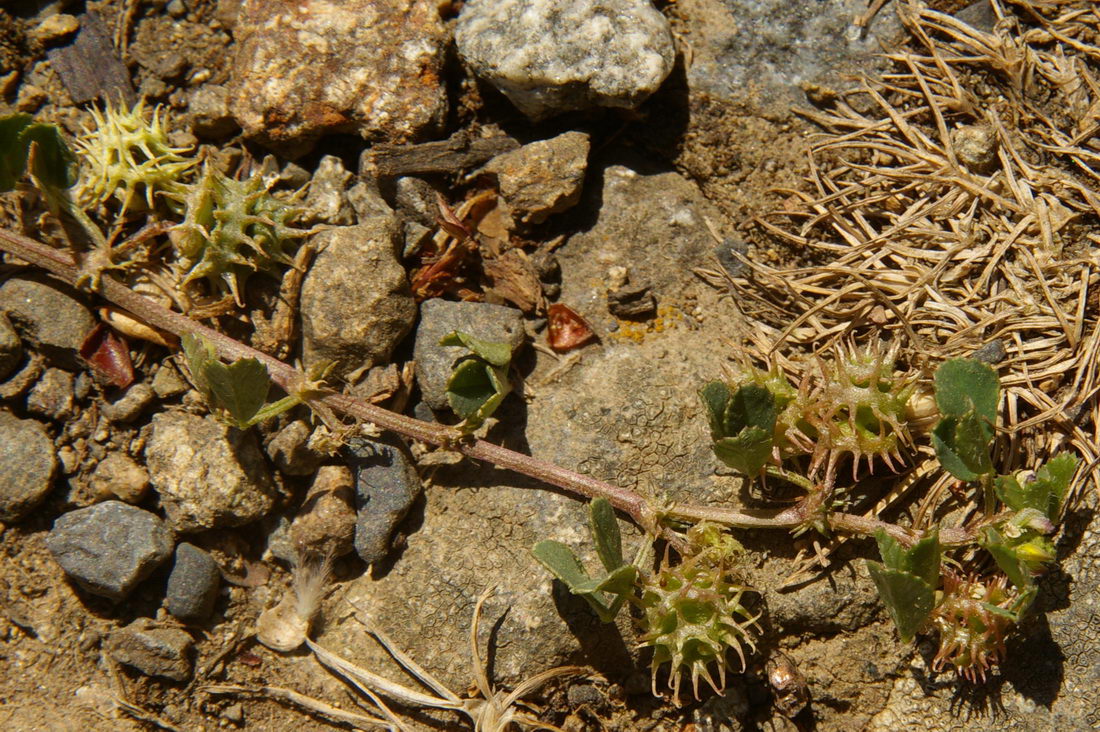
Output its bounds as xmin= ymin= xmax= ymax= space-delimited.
xmin=701 ymin=0 xmax=1100 ymax=530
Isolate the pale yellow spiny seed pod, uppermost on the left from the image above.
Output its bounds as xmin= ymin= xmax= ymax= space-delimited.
xmin=76 ymin=100 xmax=195 ymax=212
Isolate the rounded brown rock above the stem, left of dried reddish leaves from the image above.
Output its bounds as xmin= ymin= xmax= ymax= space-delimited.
xmin=300 ymin=217 xmax=416 ymax=374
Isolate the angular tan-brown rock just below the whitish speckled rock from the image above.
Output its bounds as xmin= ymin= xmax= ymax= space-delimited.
xmin=482 ymin=132 xmax=589 ymax=223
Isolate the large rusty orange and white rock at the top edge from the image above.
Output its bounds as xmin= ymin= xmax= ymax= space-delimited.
xmin=230 ymin=0 xmax=447 ymax=150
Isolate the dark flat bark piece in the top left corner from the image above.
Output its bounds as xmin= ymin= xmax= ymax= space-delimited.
xmin=46 ymin=12 xmax=138 ymax=107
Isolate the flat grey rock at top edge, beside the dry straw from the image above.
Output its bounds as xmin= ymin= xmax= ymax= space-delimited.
xmin=674 ymin=0 xmax=901 ymax=114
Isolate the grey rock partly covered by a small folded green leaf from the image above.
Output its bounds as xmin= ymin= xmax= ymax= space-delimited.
xmin=413 ymin=299 xmax=525 ymax=409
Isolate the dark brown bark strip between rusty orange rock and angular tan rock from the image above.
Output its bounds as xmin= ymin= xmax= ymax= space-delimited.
xmin=366 ymin=132 xmax=519 ymax=177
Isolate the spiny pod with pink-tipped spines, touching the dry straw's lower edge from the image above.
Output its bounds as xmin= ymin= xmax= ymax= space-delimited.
xmin=800 ymin=346 xmax=914 ymax=477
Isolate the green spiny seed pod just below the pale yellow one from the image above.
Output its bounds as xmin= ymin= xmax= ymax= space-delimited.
xmin=169 ymin=165 xmax=309 ymax=304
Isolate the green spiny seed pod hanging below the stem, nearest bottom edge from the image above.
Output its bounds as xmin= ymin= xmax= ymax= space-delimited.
xmin=636 ymin=553 xmax=759 ymax=699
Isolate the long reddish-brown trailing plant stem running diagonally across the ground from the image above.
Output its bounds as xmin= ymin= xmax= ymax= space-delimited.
xmin=0 ymin=229 xmax=974 ymax=545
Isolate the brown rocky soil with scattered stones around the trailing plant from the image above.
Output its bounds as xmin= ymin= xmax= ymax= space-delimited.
xmin=0 ymin=0 xmax=1100 ymax=731
